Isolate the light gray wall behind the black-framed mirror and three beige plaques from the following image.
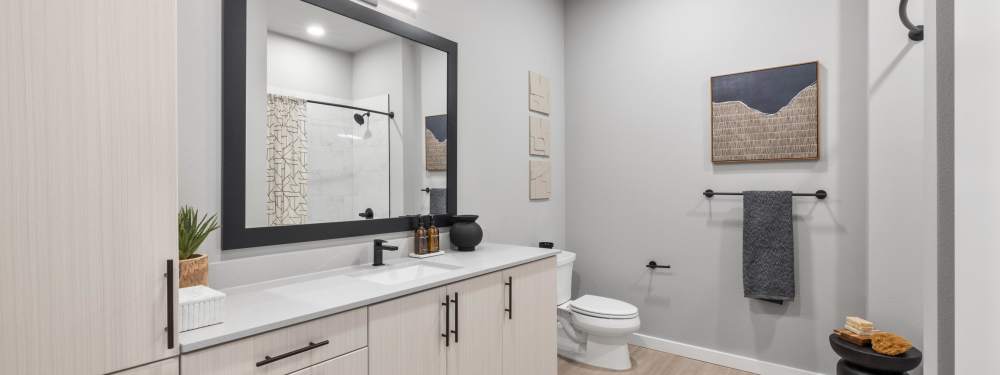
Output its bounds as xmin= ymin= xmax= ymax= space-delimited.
xmin=178 ymin=0 xmax=565 ymax=262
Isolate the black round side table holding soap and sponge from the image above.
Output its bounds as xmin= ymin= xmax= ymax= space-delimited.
xmin=830 ymin=334 xmax=924 ymax=375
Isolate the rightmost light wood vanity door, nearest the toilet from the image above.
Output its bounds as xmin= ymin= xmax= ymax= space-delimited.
xmin=502 ymin=257 xmax=557 ymax=375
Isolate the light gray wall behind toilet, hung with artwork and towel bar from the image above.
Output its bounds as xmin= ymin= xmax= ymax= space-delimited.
xmin=568 ymin=0 xmax=872 ymax=373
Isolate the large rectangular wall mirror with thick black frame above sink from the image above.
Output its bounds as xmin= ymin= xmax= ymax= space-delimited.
xmin=222 ymin=0 xmax=458 ymax=249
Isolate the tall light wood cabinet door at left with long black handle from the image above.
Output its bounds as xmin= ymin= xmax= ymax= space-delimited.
xmin=0 ymin=0 xmax=177 ymax=375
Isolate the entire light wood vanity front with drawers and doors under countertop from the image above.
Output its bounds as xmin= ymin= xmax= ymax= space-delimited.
xmin=181 ymin=257 xmax=556 ymax=375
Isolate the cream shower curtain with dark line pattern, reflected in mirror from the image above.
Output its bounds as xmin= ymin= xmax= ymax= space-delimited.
xmin=266 ymin=95 xmax=309 ymax=225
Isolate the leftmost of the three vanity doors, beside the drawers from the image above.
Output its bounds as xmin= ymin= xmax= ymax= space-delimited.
xmin=368 ymin=287 xmax=446 ymax=375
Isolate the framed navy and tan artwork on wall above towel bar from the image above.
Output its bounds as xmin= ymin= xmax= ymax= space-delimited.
xmin=712 ymin=62 xmax=819 ymax=163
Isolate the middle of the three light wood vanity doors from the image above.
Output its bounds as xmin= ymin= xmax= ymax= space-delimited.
xmin=447 ymin=272 xmax=504 ymax=375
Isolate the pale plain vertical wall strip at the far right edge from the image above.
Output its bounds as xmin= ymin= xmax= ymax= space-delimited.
xmin=949 ymin=1 xmax=1000 ymax=374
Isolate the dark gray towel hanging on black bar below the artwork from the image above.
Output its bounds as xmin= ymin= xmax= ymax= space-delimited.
xmin=743 ymin=191 xmax=795 ymax=304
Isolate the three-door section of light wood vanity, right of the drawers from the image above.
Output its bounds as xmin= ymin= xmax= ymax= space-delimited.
xmin=368 ymin=258 xmax=556 ymax=375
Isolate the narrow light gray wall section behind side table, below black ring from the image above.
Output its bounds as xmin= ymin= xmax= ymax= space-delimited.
xmin=866 ymin=0 xmax=937 ymax=362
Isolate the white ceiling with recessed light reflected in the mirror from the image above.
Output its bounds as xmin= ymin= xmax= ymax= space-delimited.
xmin=266 ymin=0 xmax=399 ymax=53
